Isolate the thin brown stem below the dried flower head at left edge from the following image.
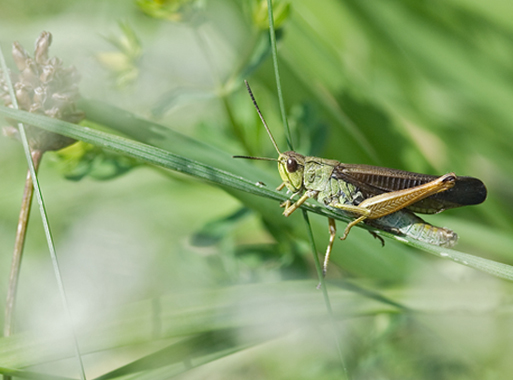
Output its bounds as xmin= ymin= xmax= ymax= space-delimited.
xmin=4 ymin=150 xmax=43 ymax=336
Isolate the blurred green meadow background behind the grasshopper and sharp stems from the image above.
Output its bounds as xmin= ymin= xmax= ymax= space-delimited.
xmin=0 ymin=0 xmax=513 ymax=379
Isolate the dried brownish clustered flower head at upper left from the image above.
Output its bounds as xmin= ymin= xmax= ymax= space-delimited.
xmin=0 ymin=32 xmax=84 ymax=151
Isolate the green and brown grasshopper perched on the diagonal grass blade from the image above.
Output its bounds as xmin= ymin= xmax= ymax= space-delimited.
xmin=234 ymin=82 xmax=487 ymax=275
